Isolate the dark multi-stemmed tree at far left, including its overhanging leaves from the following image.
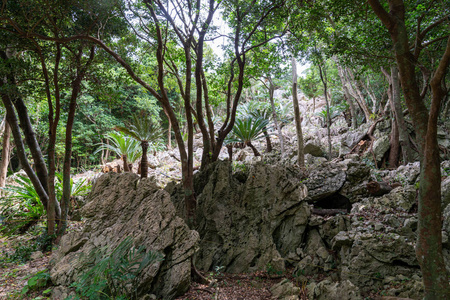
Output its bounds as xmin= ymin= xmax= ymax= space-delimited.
xmin=0 ymin=1 xmax=121 ymax=237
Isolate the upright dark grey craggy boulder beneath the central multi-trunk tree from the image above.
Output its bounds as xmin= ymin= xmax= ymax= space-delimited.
xmin=168 ymin=161 xmax=310 ymax=272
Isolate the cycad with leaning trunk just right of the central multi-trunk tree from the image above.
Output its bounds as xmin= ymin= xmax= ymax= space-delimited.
xmin=229 ymin=117 xmax=269 ymax=156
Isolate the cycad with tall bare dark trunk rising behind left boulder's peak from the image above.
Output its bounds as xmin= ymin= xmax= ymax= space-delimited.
xmin=116 ymin=115 xmax=162 ymax=178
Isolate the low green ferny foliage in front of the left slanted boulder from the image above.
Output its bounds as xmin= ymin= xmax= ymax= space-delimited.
xmin=72 ymin=237 xmax=163 ymax=300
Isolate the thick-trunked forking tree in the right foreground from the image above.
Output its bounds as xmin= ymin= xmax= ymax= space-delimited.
xmin=368 ymin=0 xmax=450 ymax=299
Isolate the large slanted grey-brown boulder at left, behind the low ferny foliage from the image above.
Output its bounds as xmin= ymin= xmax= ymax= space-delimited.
xmin=50 ymin=173 xmax=199 ymax=299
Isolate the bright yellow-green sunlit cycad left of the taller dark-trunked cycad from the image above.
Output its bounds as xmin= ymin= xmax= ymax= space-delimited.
xmin=94 ymin=132 xmax=142 ymax=172
